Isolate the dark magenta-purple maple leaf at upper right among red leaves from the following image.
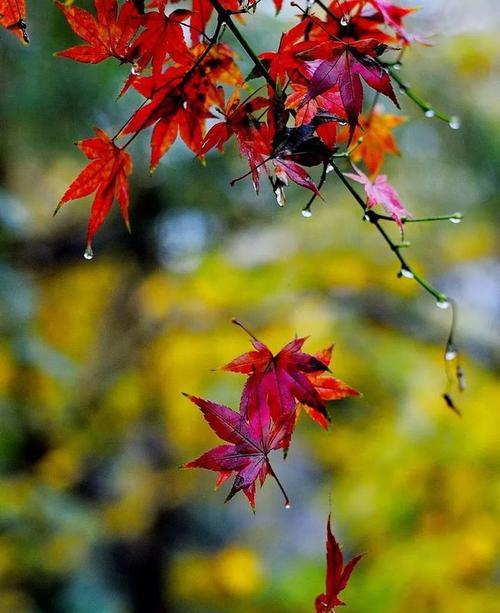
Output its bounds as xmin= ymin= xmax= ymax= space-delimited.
xmin=301 ymin=38 xmax=399 ymax=137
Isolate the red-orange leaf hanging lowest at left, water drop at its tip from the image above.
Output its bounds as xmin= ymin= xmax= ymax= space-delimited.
xmin=56 ymin=128 xmax=132 ymax=252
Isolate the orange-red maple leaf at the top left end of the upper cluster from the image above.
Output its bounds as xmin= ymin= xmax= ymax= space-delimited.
xmin=56 ymin=0 xmax=141 ymax=64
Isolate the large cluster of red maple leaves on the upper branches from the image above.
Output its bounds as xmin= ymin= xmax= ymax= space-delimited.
xmin=50 ymin=0 xmax=415 ymax=249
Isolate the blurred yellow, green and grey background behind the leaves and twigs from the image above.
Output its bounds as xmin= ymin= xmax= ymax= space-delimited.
xmin=0 ymin=0 xmax=500 ymax=613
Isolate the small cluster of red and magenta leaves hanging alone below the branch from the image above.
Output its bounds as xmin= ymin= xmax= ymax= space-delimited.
xmin=185 ymin=320 xmax=359 ymax=509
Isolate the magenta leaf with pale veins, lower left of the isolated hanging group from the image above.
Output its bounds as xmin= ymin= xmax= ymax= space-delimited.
xmin=183 ymin=394 xmax=293 ymax=510
